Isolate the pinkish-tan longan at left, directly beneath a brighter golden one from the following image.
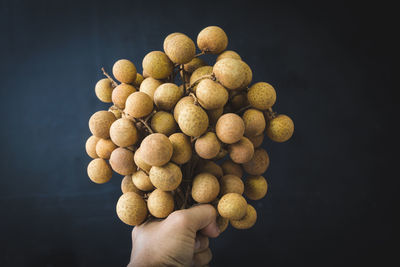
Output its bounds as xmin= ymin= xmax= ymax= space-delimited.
xmin=110 ymin=147 xmax=136 ymax=175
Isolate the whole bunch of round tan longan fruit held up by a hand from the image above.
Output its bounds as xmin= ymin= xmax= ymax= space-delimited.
xmin=86 ymin=26 xmax=294 ymax=232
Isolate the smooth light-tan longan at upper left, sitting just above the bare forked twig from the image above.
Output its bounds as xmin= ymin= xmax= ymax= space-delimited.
xmin=125 ymin=92 xmax=153 ymax=118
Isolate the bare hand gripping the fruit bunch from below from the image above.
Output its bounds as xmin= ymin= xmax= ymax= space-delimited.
xmin=128 ymin=204 xmax=220 ymax=267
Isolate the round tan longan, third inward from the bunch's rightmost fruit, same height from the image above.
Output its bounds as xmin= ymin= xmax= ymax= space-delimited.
xmin=215 ymin=113 xmax=245 ymax=144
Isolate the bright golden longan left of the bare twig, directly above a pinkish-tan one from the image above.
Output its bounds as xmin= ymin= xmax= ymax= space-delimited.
xmin=110 ymin=118 xmax=139 ymax=147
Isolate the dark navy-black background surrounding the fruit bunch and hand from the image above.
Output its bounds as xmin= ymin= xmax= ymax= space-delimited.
xmin=0 ymin=0 xmax=399 ymax=266
